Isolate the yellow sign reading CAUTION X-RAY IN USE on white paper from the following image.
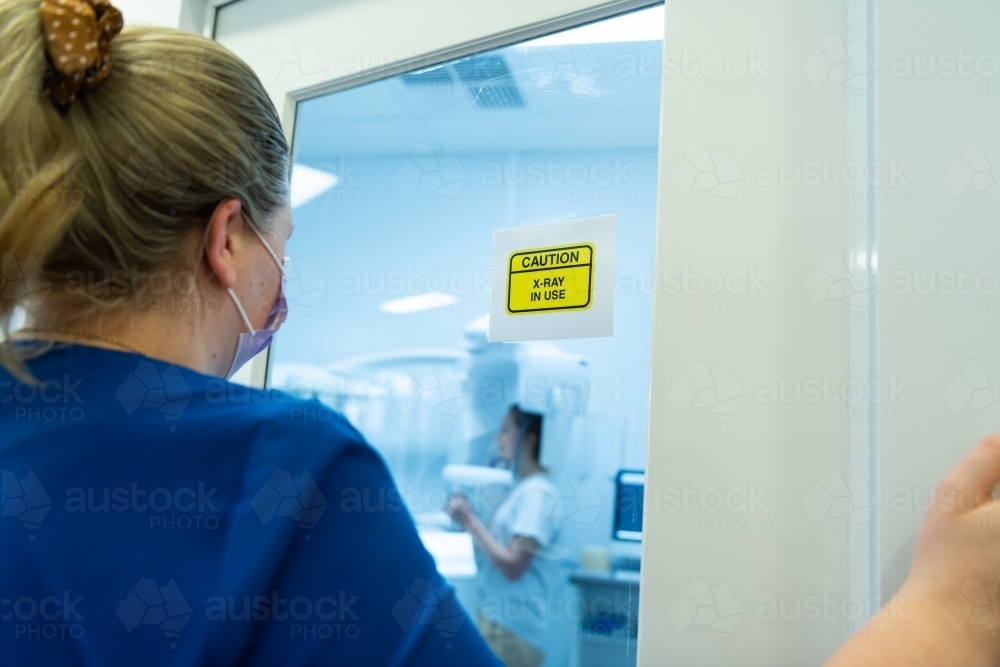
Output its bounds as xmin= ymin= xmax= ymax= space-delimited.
xmin=507 ymin=243 xmax=594 ymax=315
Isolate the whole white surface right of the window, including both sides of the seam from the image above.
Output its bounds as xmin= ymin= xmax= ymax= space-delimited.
xmin=640 ymin=0 xmax=1000 ymax=665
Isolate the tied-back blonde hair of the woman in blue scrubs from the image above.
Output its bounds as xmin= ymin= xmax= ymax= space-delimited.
xmin=0 ymin=0 xmax=290 ymax=377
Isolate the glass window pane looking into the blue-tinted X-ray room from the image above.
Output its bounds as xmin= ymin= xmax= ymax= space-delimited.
xmin=271 ymin=6 xmax=663 ymax=665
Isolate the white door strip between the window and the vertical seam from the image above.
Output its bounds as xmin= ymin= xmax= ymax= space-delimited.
xmin=639 ymin=0 xmax=867 ymax=666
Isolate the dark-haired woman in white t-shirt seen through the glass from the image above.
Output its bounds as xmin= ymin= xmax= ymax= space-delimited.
xmin=445 ymin=405 xmax=561 ymax=667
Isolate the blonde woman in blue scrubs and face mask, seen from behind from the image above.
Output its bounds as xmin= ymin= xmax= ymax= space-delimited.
xmin=0 ymin=0 xmax=497 ymax=667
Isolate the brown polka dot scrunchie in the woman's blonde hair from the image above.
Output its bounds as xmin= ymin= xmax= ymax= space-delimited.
xmin=40 ymin=0 xmax=123 ymax=105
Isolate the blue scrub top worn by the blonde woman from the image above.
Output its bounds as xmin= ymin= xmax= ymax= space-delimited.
xmin=0 ymin=345 xmax=500 ymax=667
